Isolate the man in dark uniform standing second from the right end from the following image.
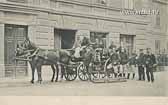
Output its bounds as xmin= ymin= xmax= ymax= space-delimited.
xmin=137 ymin=49 xmax=145 ymax=81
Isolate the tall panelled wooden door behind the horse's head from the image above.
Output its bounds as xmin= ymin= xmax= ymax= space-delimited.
xmin=5 ymin=25 xmax=28 ymax=77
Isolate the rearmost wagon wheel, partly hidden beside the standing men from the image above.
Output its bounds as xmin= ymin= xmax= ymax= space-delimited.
xmin=104 ymin=58 xmax=114 ymax=78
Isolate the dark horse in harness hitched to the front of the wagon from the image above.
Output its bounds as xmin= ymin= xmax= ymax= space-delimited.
xmin=16 ymin=38 xmax=71 ymax=83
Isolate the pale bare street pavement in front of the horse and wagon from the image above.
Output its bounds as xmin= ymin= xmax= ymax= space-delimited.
xmin=0 ymin=71 xmax=168 ymax=96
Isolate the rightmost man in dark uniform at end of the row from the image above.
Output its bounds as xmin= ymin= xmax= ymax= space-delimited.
xmin=145 ymin=48 xmax=156 ymax=82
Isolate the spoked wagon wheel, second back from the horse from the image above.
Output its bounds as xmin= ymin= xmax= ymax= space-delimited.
xmin=77 ymin=63 xmax=89 ymax=81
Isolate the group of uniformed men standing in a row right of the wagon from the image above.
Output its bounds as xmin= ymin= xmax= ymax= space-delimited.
xmin=109 ymin=41 xmax=157 ymax=82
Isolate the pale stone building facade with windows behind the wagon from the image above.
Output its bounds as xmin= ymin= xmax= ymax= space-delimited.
xmin=0 ymin=0 xmax=168 ymax=77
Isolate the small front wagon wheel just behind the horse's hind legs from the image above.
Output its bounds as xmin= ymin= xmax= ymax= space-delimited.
xmin=64 ymin=67 xmax=77 ymax=81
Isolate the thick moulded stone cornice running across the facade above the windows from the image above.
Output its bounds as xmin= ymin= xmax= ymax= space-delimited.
xmin=0 ymin=3 xmax=149 ymax=25
